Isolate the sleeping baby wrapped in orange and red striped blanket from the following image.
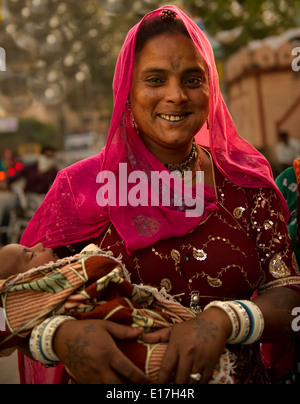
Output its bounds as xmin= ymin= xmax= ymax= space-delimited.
xmin=0 ymin=244 xmax=237 ymax=383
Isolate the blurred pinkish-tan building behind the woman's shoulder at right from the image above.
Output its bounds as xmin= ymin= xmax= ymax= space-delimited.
xmin=225 ymin=28 xmax=300 ymax=172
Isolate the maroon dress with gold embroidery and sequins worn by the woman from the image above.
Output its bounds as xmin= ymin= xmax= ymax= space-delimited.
xmin=85 ymin=163 xmax=300 ymax=384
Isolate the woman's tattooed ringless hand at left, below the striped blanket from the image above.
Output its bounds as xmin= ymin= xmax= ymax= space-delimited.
xmin=53 ymin=320 xmax=150 ymax=384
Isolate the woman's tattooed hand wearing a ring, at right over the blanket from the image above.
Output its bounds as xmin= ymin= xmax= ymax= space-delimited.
xmin=143 ymin=308 xmax=232 ymax=384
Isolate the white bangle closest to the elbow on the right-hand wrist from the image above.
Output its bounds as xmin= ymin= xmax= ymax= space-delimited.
xmin=238 ymin=300 xmax=265 ymax=345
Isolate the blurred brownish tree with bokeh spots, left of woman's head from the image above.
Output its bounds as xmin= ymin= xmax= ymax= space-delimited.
xmin=0 ymin=0 xmax=166 ymax=113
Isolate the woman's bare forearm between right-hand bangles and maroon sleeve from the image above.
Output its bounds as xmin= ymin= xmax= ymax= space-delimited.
xmin=254 ymin=287 xmax=300 ymax=342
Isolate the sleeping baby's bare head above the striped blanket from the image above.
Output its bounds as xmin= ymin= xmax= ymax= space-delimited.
xmin=0 ymin=244 xmax=58 ymax=279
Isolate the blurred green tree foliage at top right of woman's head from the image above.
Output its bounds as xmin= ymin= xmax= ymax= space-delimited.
xmin=183 ymin=0 xmax=300 ymax=56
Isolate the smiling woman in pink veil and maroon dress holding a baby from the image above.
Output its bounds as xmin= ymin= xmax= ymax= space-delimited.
xmin=21 ymin=6 xmax=300 ymax=383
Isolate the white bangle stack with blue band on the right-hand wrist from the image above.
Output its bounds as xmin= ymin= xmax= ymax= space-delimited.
xmin=204 ymin=300 xmax=265 ymax=345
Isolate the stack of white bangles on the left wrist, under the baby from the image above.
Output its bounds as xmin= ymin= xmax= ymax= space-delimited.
xmin=29 ymin=316 xmax=75 ymax=366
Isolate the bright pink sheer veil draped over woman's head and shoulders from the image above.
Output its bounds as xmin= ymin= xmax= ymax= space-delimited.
xmin=20 ymin=6 xmax=288 ymax=383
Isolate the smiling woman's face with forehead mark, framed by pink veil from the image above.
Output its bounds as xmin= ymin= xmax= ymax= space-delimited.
xmin=130 ymin=33 xmax=210 ymax=162
